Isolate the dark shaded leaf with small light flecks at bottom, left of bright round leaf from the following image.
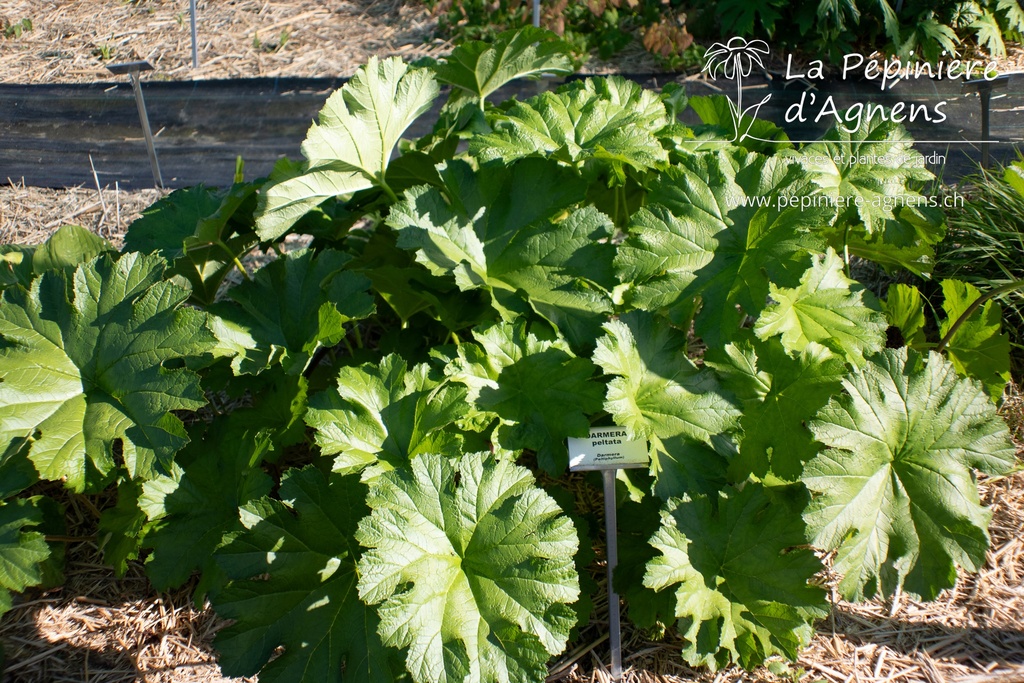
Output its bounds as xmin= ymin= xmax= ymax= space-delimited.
xmin=210 ymin=467 xmax=400 ymax=683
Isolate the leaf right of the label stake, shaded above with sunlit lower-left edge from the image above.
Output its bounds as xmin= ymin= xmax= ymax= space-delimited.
xmin=644 ymin=482 xmax=828 ymax=671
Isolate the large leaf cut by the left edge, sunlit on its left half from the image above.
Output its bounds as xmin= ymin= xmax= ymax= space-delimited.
xmin=0 ymin=254 xmax=214 ymax=490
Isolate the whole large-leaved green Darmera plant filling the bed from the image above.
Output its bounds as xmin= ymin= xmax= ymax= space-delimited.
xmin=0 ymin=32 xmax=1014 ymax=683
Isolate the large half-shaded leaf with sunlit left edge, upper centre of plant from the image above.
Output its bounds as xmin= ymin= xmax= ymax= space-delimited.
xmin=388 ymin=159 xmax=614 ymax=347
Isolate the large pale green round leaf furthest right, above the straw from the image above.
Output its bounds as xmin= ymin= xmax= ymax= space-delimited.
xmin=802 ymin=348 xmax=1015 ymax=600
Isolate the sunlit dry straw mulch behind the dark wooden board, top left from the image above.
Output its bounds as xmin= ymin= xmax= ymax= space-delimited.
xmin=0 ymin=0 xmax=452 ymax=83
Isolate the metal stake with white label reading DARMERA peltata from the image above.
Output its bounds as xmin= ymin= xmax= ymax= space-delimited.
xmin=568 ymin=427 xmax=649 ymax=683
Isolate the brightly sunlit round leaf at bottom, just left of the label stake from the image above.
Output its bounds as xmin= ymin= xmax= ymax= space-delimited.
xmin=356 ymin=454 xmax=580 ymax=683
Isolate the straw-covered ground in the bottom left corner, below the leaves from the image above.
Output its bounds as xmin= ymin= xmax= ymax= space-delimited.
xmin=0 ymin=489 xmax=247 ymax=683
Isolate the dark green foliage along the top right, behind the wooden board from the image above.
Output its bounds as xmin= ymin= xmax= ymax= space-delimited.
xmin=424 ymin=0 xmax=1024 ymax=71
